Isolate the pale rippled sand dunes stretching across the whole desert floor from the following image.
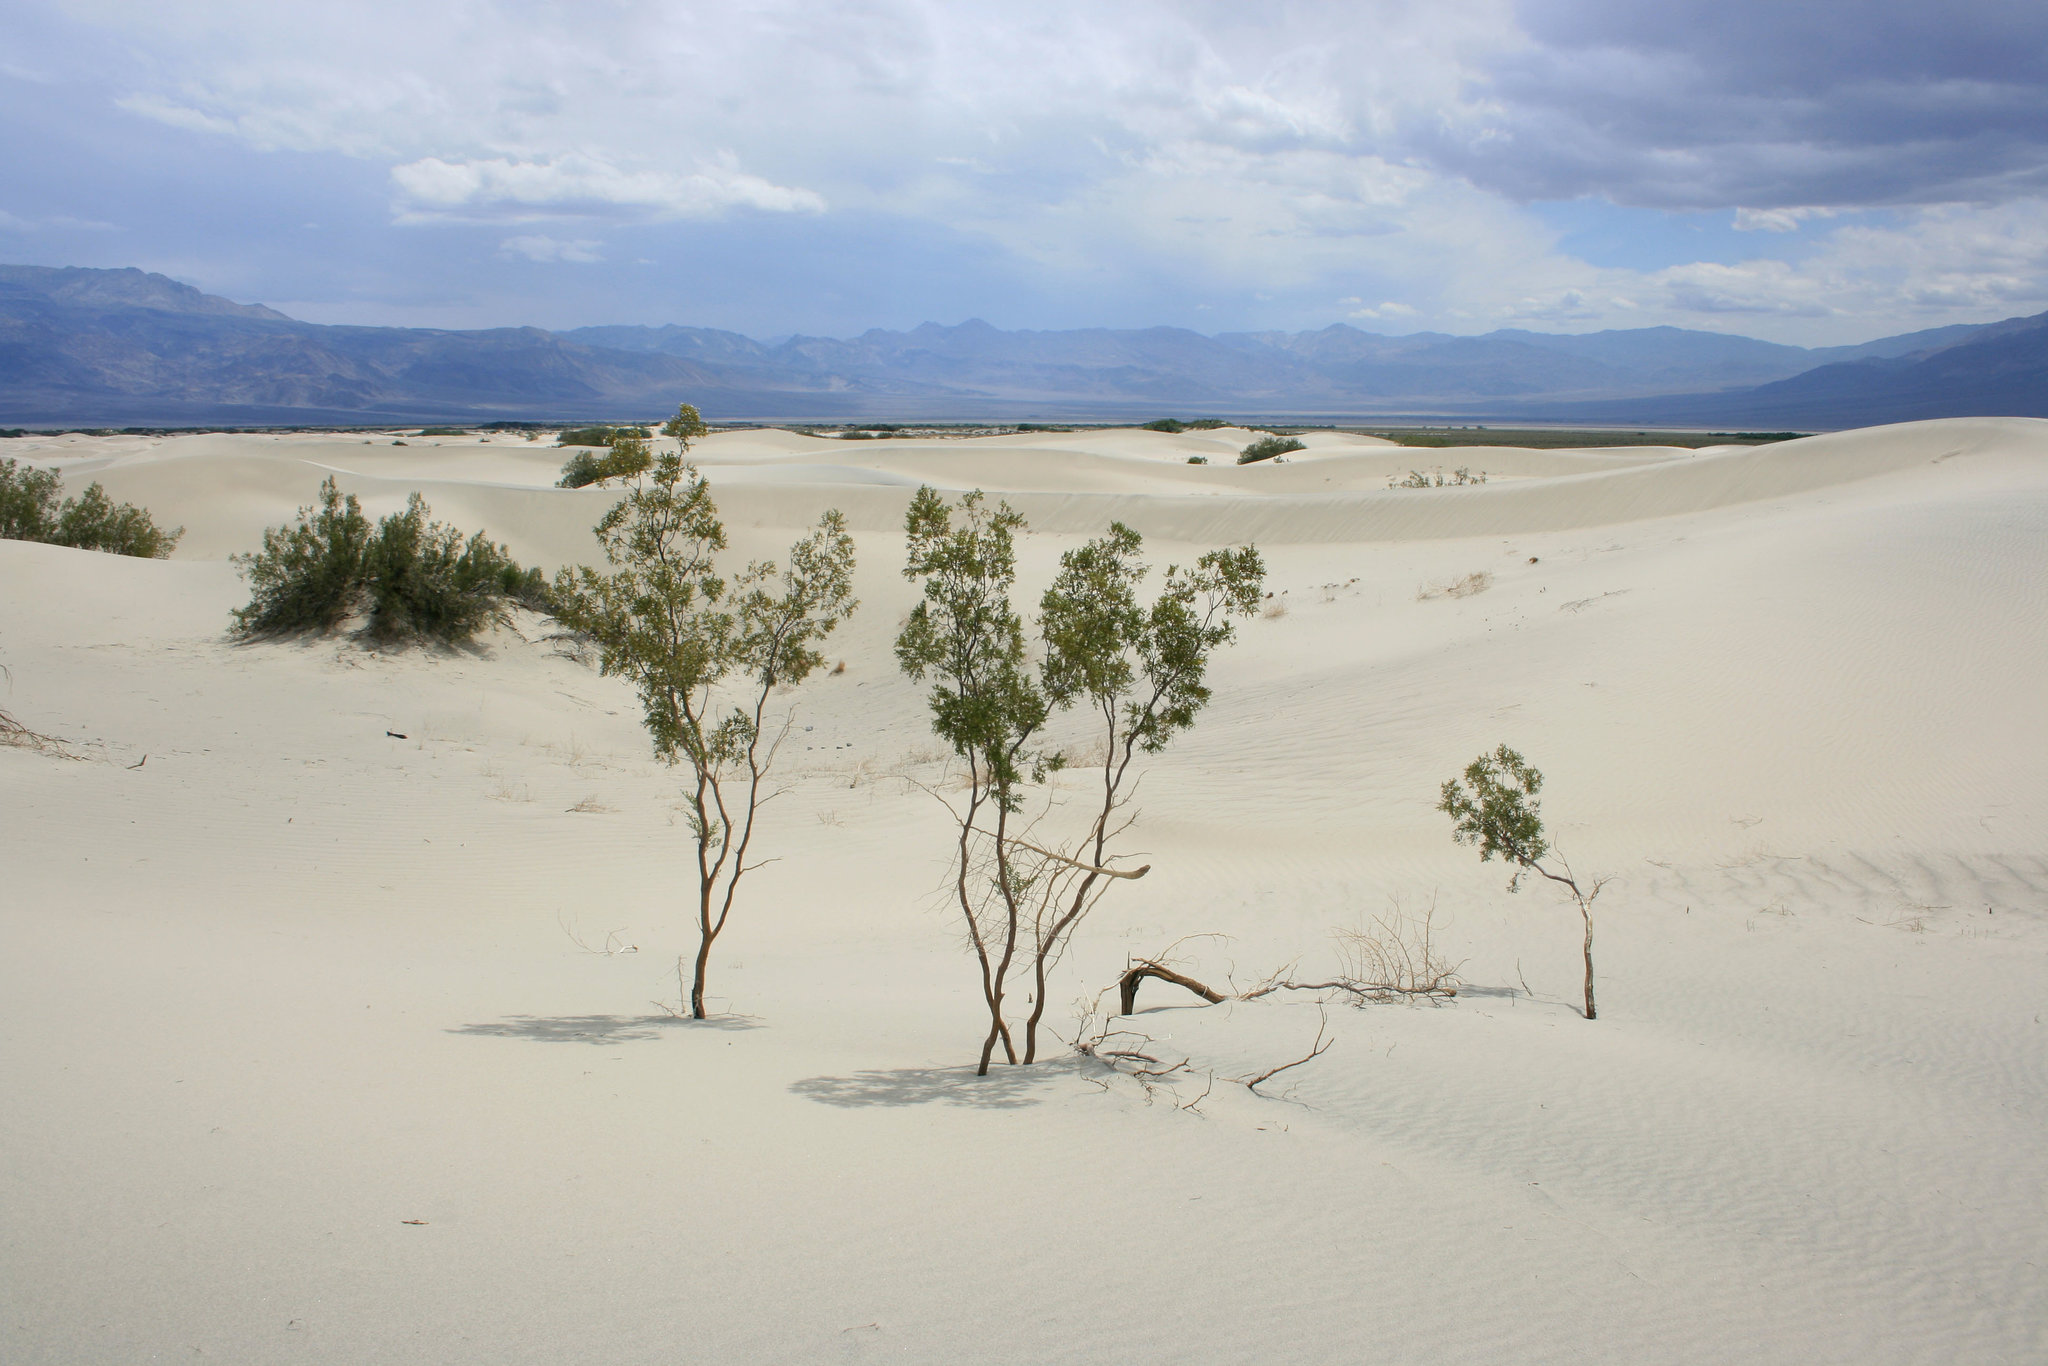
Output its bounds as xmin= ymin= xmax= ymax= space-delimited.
xmin=0 ymin=420 xmax=2048 ymax=1364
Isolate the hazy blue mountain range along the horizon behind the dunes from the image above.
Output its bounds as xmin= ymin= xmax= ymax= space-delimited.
xmin=0 ymin=266 xmax=2048 ymax=428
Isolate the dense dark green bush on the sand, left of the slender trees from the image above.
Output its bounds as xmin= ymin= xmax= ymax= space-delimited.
xmin=233 ymin=477 xmax=551 ymax=645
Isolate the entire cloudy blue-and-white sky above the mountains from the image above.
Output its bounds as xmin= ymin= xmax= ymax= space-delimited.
xmin=0 ymin=0 xmax=2048 ymax=344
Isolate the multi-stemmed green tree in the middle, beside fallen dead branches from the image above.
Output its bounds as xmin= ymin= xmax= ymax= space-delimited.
xmin=897 ymin=487 xmax=1264 ymax=1075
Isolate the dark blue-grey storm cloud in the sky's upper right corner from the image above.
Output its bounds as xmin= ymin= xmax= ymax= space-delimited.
xmin=1419 ymin=0 xmax=2048 ymax=209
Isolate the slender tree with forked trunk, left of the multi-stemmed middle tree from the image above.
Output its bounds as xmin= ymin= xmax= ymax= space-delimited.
xmin=555 ymin=405 xmax=858 ymax=1020
